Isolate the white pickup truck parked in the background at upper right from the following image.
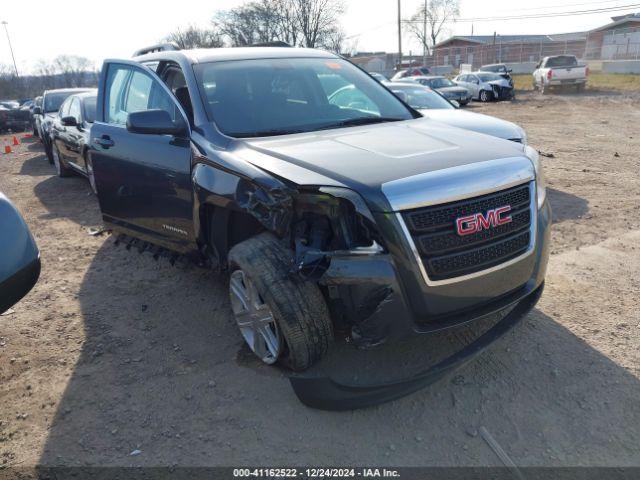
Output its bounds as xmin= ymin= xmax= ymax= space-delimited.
xmin=533 ymin=55 xmax=589 ymax=94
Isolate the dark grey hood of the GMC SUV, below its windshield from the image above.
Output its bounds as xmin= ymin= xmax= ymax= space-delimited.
xmin=234 ymin=118 xmax=524 ymax=211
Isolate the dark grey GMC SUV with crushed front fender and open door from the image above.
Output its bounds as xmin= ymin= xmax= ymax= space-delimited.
xmin=89 ymin=45 xmax=550 ymax=408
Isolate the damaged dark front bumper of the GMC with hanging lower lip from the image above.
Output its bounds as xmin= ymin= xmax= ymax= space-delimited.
xmin=290 ymin=202 xmax=551 ymax=410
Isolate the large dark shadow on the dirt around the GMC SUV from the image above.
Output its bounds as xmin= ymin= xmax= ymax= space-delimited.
xmin=39 ymin=234 xmax=640 ymax=471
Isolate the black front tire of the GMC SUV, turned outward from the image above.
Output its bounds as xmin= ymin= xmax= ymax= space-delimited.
xmin=229 ymin=233 xmax=333 ymax=371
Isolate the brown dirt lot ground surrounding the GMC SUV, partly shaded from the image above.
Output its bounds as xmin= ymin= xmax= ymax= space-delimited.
xmin=0 ymin=93 xmax=640 ymax=475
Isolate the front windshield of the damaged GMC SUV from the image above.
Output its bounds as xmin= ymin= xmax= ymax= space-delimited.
xmin=194 ymin=58 xmax=413 ymax=138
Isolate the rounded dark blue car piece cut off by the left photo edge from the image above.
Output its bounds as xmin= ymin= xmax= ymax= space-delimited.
xmin=0 ymin=193 xmax=40 ymax=313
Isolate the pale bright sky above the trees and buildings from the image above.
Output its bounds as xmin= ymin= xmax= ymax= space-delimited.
xmin=0 ymin=0 xmax=640 ymax=73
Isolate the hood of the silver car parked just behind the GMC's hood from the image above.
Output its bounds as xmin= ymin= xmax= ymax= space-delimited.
xmin=420 ymin=109 xmax=523 ymax=140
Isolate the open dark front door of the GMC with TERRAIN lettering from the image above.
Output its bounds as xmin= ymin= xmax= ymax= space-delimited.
xmin=90 ymin=60 xmax=195 ymax=252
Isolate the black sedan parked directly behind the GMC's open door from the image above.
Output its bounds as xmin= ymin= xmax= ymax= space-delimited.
xmin=50 ymin=90 xmax=97 ymax=193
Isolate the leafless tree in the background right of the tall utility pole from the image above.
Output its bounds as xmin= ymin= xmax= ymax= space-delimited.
xmin=408 ymin=0 xmax=460 ymax=52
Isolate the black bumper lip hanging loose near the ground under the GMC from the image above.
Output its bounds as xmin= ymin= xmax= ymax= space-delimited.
xmin=289 ymin=284 xmax=544 ymax=411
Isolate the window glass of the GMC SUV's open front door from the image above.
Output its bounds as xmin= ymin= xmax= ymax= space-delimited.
xmin=105 ymin=65 xmax=180 ymax=125
